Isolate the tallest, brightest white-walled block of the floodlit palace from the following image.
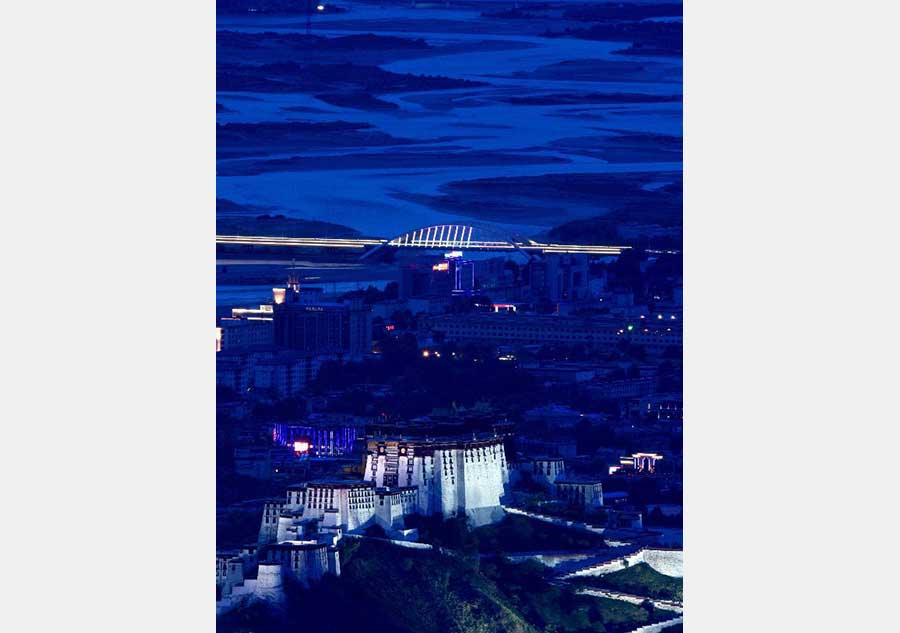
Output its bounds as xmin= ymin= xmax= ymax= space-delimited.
xmin=364 ymin=438 xmax=508 ymax=525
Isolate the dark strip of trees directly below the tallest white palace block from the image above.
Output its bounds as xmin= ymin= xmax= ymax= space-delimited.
xmin=407 ymin=514 xmax=606 ymax=554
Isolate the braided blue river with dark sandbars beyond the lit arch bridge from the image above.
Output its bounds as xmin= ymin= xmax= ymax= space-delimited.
xmin=218 ymin=3 xmax=681 ymax=236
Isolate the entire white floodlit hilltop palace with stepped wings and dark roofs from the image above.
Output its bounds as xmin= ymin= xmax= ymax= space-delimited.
xmin=216 ymin=436 xmax=509 ymax=611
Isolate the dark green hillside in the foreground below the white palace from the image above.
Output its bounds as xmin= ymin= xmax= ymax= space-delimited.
xmin=217 ymin=540 xmax=668 ymax=633
